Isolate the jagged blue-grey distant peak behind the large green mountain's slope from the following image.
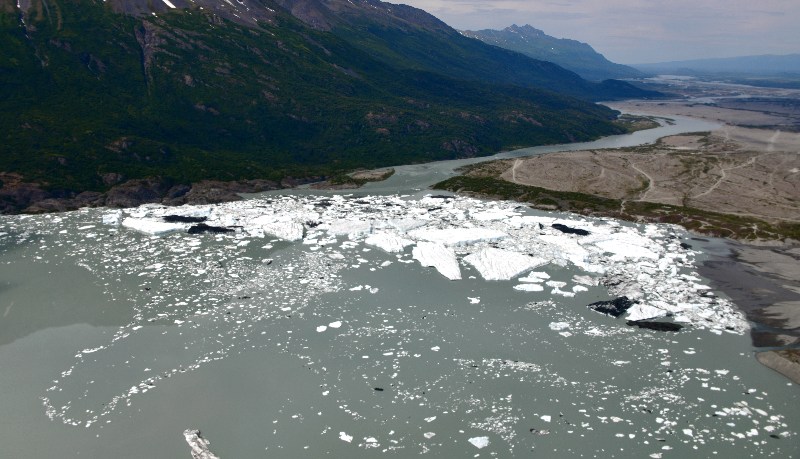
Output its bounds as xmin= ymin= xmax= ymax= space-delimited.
xmin=461 ymin=24 xmax=642 ymax=81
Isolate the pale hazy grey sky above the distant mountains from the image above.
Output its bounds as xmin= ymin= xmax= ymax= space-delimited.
xmin=398 ymin=0 xmax=800 ymax=64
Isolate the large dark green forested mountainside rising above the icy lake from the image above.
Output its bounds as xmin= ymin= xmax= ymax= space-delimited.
xmin=0 ymin=0 xmax=652 ymax=210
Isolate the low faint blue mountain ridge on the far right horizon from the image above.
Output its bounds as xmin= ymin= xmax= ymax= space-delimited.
xmin=635 ymin=54 xmax=800 ymax=76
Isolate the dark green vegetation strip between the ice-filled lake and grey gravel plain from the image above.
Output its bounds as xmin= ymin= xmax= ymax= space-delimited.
xmin=433 ymin=175 xmax=800 ymax=240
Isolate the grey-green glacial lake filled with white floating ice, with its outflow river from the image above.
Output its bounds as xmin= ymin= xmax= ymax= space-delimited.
xmin=0 ymin=112 xmax=800 ymax=459
